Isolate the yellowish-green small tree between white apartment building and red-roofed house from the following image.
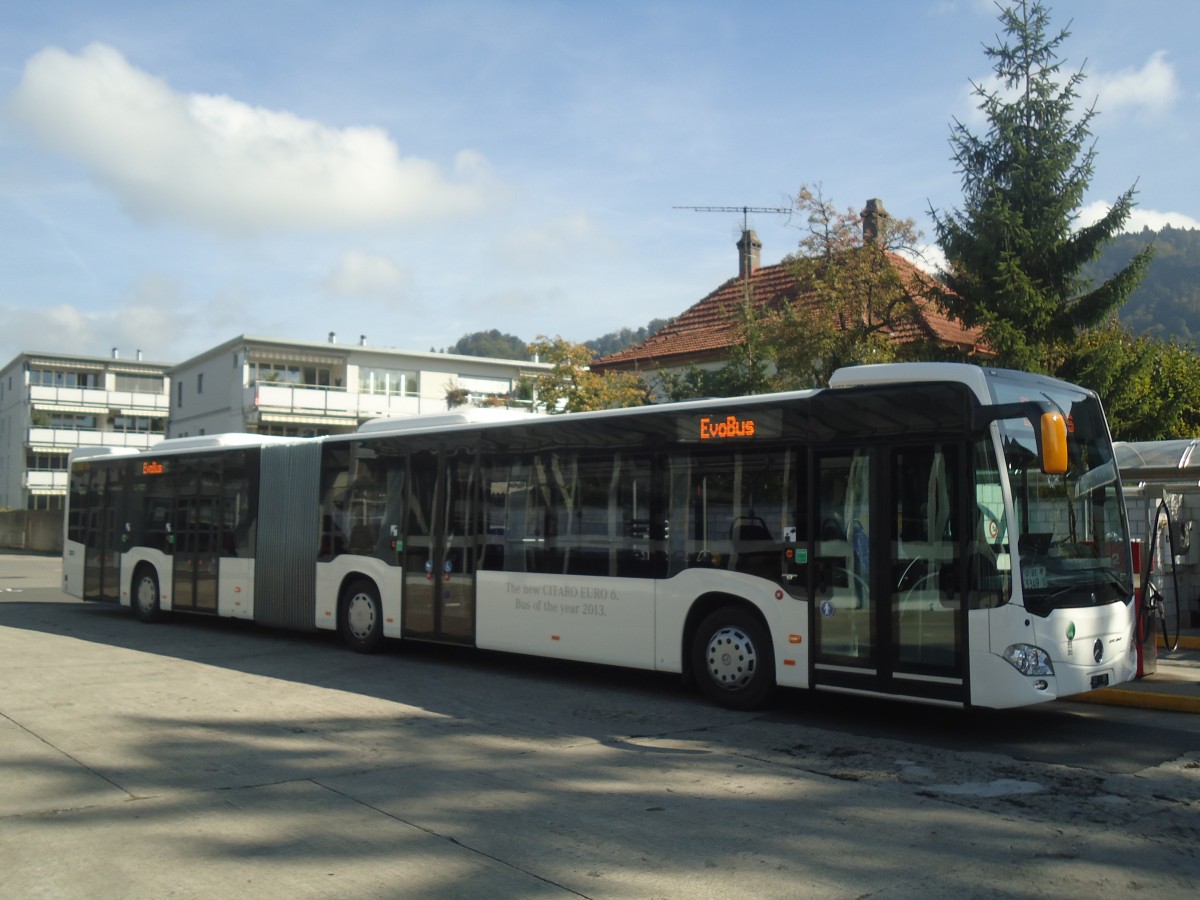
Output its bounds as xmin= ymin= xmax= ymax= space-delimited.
xmin=529 ymin=335 xmax=649 ymax=413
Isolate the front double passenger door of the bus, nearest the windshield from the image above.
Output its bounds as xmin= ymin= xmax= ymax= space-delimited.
xmin=812 ymin=443 xmax=965 ymax=702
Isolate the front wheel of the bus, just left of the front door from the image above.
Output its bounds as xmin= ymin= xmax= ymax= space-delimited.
xmin=691 ymin=606 xmax=775 ymax=709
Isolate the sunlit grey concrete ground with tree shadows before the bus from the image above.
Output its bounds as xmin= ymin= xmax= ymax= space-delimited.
xmin=0 ymin=556 xmax=1200 ymax=900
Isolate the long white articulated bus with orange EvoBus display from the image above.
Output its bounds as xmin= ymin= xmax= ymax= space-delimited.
xmin=64 ymin=364 xmax=1135 ymax=708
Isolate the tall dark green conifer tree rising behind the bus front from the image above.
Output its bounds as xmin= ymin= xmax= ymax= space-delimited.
xmin=931 ymin=0 xmax=1150 ymax=371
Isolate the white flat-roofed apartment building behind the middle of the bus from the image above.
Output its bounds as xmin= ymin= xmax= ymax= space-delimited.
xmin=168 ymin=334 xmax=551 ymax=438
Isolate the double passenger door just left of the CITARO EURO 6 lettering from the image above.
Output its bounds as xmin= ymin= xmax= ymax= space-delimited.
xmin=403 ymin=451 xmax=481 ymax=643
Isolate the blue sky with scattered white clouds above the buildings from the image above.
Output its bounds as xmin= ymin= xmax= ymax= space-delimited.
xmin=0 ymin=0 xmax=1200 ymax=364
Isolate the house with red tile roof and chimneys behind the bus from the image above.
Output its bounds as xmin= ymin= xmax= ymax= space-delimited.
xmin=592 ymin=200 xmax=986 ymax=384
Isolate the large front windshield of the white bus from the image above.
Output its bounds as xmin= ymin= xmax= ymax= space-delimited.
xmin=994 ymin=380 xmax=1133 ymax=616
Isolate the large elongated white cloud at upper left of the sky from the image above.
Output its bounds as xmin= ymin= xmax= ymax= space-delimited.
xmin=8 ymin=43 xmax=504 ymax=232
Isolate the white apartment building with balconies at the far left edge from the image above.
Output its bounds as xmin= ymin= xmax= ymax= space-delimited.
xmin=0 ymin=349 xmax=169 ymax=510
